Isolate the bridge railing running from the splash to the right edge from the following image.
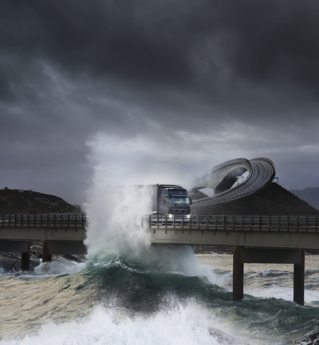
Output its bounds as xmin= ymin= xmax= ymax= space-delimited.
xmin=142 ymin=214 xmax=319 ymax=233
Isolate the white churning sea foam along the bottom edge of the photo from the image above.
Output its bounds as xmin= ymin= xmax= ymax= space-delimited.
xmin=0 ymin=303 xmax=248 ymax=345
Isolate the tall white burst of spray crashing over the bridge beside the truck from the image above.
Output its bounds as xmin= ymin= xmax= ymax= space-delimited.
xmin=85 ymin=136 xmax=224 ymax=284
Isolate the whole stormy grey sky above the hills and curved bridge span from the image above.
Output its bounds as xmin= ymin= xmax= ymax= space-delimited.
xmin=0 ymin=0 xmax=319 ymax=204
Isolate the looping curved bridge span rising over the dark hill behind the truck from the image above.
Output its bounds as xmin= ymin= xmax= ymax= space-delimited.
xmin=193 ymin=157 xmax=276 ymax=206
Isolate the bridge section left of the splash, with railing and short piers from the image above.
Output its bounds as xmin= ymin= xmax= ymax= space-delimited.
xmin=0 ymin=213 xmax=86 ymax=270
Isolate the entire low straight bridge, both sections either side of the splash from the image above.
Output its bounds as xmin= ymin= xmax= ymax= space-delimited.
xmin=0 ymin=210 xmax=319 ymax=305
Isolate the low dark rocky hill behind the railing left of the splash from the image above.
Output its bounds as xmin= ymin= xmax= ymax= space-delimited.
xmin=0 ymin=188 xmax=81 ymax=214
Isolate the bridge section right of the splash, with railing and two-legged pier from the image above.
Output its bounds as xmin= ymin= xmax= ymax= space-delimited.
xmin=146 ymin=215 xmax=319 ymax=305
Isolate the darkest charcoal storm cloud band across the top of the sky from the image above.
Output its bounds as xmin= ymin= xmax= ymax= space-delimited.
xmin=0 ymin=0 xmax=319 ymax=89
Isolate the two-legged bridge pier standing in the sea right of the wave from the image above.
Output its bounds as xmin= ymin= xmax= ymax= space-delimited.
xmin=233 ymin=247 xmax=305 ymax=305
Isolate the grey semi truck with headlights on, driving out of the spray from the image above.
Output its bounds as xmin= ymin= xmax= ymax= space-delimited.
xmin=152 ymin=184 xmax=192 ymax=216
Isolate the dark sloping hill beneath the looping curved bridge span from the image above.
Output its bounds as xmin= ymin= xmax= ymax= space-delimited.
xmin=190 ymin=183 xmax=319 ymax=216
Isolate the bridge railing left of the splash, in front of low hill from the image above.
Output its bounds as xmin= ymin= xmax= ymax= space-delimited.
xmin=0 ymin=213 xmax=87 ymax=229
